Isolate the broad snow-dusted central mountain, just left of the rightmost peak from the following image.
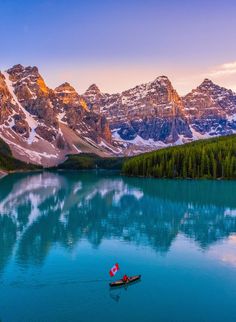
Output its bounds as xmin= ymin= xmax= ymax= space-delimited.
xmin=84 ymin=76 xmax=192 ymax=143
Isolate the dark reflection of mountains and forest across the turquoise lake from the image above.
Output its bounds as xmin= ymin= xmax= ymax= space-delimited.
xmin=0 ymin=172 xmax=236 ymax=271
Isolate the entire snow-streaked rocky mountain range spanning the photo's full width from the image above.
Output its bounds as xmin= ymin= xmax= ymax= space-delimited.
xmin=0 ymin=65 xmax=236 ymax=167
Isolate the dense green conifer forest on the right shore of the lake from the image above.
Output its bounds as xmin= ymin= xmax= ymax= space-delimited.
xmin=123 ymin=135 xmax=236 ymax=179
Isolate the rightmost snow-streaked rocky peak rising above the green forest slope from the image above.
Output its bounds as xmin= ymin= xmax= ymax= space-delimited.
xmin=183 ymin=79 xmax=236 ymax=136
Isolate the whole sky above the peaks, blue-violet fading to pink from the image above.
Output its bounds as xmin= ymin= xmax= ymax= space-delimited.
xmin=0 ymin=0 xmax=236 ymax=94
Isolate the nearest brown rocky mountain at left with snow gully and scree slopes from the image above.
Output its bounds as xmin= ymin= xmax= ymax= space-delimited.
xmin=0 ymin=65 xmax=112 ymax=166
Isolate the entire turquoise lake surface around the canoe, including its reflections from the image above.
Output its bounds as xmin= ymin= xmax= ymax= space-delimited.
xmin=0 ymin=172 xmax=236 ymax=322
